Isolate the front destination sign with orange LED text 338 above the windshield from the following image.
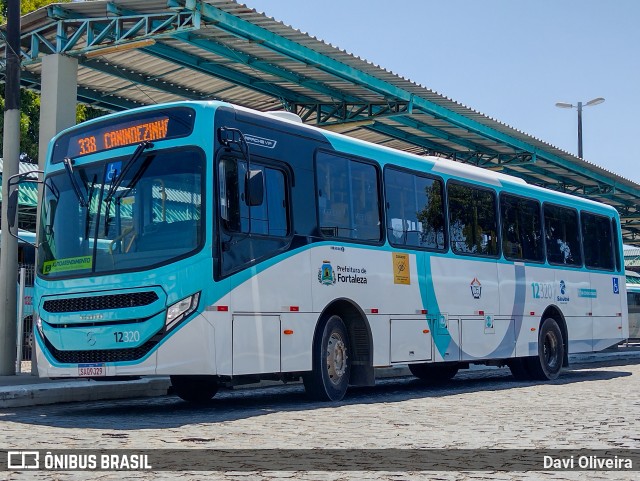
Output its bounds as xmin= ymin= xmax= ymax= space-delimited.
xmin=52 ymin=108 xmax=195 ymax=163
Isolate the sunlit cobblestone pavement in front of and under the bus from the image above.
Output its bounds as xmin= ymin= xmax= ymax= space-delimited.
xmin=0 ymin=361 xmax=640 ymax=481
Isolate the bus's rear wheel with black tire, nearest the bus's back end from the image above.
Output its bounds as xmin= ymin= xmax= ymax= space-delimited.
xmin=526 ymin=318 xmax=564 ymax=381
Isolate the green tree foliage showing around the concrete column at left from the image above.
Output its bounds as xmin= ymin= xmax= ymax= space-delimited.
xmin=0 ymin=0 xmax=105 ymax=162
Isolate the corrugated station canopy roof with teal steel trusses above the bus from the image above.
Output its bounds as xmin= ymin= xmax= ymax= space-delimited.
xmin=0 ymin=0 xmax=640 ymax=245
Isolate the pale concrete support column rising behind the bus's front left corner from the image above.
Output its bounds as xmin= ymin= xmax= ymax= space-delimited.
xmin=31 ymin=54 xmax=78 ymax=374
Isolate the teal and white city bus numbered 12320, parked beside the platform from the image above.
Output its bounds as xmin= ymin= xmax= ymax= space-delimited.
xmin=16 ymin=102 xmax=629 ymax=401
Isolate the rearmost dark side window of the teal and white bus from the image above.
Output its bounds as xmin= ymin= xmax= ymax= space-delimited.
xmin=580 ymin=212 xmax=614 ymax=271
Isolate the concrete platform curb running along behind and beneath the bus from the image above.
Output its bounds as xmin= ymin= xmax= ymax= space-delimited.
xmin=0 ymin=349 xmax=640 ymax=409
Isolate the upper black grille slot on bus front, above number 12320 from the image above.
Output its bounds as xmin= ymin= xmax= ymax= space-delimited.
xmin=42 ymin=291 xmax=158 ymax=313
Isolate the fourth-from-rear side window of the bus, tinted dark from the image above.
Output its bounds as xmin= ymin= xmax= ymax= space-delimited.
xmin=447 ymin=183 xmax=498 ymax=257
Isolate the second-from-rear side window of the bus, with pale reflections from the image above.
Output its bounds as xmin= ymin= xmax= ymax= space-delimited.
xmin=544 ymin=204 xmax=582 ymax=266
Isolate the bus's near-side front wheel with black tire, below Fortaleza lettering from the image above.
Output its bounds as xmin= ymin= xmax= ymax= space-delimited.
xmin=302 ymin=316 xmax=351 ymax=401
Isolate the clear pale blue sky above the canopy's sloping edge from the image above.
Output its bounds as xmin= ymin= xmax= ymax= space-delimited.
xmin=245 ymin=0 xmax=640 ymax=183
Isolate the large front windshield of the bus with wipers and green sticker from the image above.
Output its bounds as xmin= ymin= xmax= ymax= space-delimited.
xmin=38 ymin=148 xmax=205 ymax=278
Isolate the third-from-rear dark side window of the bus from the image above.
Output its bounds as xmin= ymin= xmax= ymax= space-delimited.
xmin=500 ymin=194 xmax=544 ymax=262
